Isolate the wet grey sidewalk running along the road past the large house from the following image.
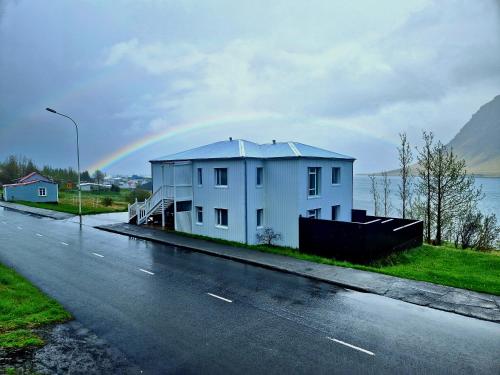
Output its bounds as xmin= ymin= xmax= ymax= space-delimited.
xmin=96 ymin=223 xmax=500 ymax=323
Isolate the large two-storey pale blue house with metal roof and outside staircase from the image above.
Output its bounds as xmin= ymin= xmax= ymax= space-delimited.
xmin=129 ymin=138 xmax=355 ymax=247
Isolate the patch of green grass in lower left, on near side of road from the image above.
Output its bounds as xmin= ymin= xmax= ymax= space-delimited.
xmin=0 ymin=264 xmax=71 ymax=348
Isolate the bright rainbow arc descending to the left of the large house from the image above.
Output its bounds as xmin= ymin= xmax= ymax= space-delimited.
xmin=88 ymin=113 xmax=276 ymax=172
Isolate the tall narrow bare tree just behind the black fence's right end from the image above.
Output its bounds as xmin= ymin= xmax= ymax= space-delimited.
xmin=398 ymin=133 xmax=413 ymax=219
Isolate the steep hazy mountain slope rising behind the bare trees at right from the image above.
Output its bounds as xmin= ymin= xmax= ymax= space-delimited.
xmin=448 ymin=95 xmax=500 ymax=176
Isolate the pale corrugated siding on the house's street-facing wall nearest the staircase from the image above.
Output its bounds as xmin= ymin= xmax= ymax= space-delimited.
xmin=189 ymin=160 xmax=245 ymax=242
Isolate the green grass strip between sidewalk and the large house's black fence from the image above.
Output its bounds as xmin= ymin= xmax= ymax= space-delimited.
xmin=168 ymin=232 xmax=500 ymax=295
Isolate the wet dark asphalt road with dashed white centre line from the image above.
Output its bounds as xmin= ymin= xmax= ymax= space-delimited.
xmin=0 ymin=208 xmax=500 ymax=374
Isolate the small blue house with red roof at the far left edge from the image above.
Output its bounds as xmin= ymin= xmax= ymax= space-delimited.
xmin=3 ymin=172 xmax=59 ymax=203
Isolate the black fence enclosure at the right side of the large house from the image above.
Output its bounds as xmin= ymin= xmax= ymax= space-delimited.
xmin=299 ymin=210 xmax=423 ymax=263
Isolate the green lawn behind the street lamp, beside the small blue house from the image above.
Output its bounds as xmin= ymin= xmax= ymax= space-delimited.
xmin=16 ymin=190 xmax=130 ymax=215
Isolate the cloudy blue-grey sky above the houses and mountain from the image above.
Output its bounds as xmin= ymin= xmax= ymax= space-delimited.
xmin=0 ymin=0 xmax=500 ymax=173
